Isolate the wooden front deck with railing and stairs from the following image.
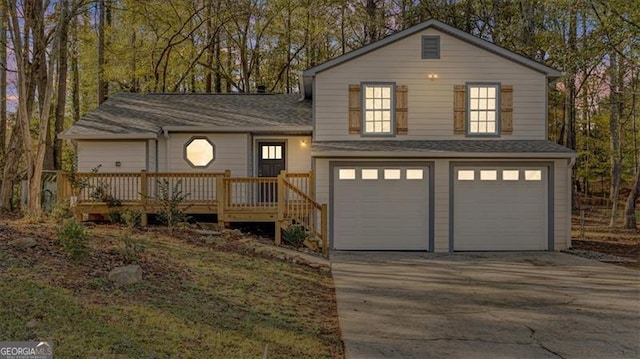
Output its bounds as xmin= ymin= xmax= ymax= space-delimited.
xmin=57 ymin=171 xmax=328 ymax=253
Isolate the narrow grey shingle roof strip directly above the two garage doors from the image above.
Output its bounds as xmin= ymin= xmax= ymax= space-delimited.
xmin=312 ymin=140 xmax=575 ymax=157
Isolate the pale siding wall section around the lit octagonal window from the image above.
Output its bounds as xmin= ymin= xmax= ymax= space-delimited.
xmin=165 ymin=133 xmax=249 ymax=177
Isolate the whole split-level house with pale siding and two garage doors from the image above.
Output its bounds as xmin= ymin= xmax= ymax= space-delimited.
xmin=61 ymin=20 xmax=575 ymax=252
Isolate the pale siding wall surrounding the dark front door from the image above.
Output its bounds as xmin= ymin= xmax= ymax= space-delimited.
xmin=251 ymin=136 xmax=311 ymax=175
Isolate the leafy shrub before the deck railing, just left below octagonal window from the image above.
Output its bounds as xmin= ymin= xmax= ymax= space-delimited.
xmin=155 ymin=179 xmax=191 ymax=232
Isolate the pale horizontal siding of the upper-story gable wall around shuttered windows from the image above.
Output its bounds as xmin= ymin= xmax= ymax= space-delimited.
xmin=314 ymin=29 xmax=546 ymax=141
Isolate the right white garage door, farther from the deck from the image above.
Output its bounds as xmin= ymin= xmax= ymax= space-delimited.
xmin=453 ymin=167 xmax=548 ymax=251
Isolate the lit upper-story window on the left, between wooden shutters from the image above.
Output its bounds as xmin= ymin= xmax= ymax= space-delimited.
xmin=362 ymin=84 xmax=395 ymax=135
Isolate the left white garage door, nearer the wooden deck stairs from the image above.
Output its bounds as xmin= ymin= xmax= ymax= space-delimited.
xmin=333 ymin=165 xmax=429 ymax=250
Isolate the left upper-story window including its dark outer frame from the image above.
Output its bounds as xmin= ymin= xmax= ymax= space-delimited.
xmin=360 ymin=82 xmax=396 ymax=136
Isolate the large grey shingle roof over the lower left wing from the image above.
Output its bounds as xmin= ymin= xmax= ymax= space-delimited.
xmin=60 ymin=93 xmax=311 ymax=138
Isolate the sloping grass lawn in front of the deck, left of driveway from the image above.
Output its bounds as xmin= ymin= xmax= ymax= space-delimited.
xmin=0 ymin=220 xmax=343 ymax=358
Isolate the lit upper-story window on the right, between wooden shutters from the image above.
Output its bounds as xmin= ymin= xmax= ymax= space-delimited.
xmin=466 ymin=84 xmax=500 ymax=135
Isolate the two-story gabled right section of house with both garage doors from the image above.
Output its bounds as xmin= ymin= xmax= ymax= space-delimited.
xmin=303 ymin=20 xmax=575 ymax=252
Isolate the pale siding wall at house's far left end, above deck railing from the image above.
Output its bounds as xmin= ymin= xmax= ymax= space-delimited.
xmin=78 ymin=140 xmax=147 ymax=172
